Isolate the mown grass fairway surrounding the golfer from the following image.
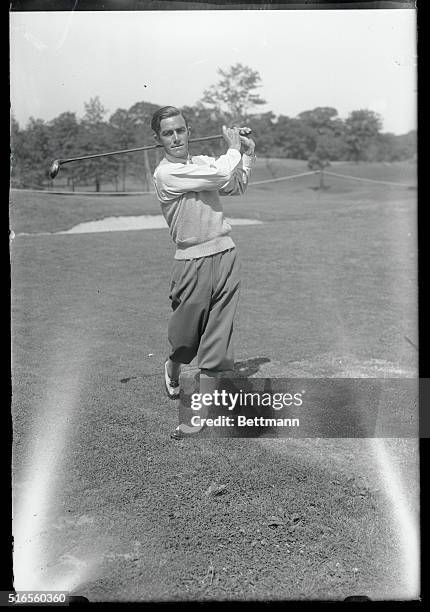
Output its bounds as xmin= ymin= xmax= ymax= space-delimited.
xmin=11 ymin=160 xmax=418 ymax=601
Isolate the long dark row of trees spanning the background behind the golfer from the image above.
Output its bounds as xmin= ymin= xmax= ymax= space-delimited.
xmin=11 ymin=64 xmax=416 ymax=191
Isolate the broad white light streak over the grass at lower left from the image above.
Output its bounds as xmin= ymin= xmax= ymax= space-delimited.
xmin=13 ymin=342 xmax=96 ymax=591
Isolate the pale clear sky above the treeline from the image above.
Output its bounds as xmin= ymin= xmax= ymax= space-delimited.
xmin=10 ymin=9 xmax=417 ymax=134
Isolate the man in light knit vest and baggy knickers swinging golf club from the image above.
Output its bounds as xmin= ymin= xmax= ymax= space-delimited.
xmin=151 ymin=106 xmax=255 ymax=408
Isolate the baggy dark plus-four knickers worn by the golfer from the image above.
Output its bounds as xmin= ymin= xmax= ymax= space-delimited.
xmin=168 ymin=248 xmax=240 ymax=372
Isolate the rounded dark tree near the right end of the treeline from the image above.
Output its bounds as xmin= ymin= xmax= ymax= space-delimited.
xmin=345 ymin=109 xmax=382 ymax=163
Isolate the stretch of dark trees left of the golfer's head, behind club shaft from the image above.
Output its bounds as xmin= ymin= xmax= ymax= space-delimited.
xmin=11 ymin=97 xmax=163 ymax=191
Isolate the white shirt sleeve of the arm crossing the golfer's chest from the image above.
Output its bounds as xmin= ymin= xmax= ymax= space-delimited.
xmin=154 ymin=149 xmax=241 ymax=198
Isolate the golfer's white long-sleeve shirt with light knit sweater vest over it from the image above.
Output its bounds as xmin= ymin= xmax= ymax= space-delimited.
xmin=154 ymin=149 xmax=255 ymax=259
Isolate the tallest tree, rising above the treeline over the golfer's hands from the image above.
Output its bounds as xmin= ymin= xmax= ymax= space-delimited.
xmin=202 ymin=63 xmax=266 ymax=124
